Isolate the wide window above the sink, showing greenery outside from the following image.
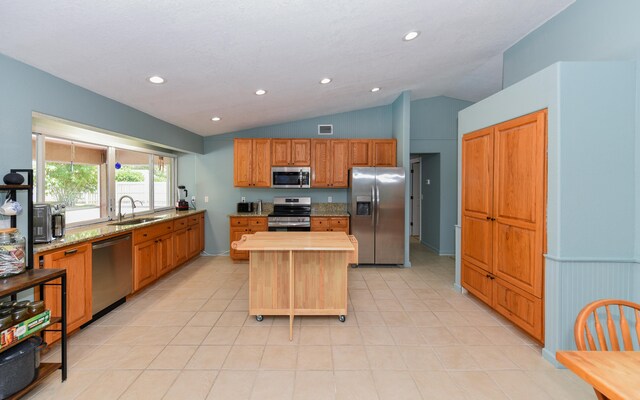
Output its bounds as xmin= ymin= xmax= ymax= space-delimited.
xmin=32 ymin=134 xmax=175 ymax=226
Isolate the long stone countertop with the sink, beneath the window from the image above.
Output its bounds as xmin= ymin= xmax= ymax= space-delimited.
xmin=33 ymin=210 xmax=204 ymax=253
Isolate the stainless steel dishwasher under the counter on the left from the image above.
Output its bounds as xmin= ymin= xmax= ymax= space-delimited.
xmin=92 ymin=234 xmax=133 ymax=319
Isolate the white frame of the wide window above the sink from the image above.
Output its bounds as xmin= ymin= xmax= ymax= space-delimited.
xmin=32 ymin=132 xmax=178 ymax=228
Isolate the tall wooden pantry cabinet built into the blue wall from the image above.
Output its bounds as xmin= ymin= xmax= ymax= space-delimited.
xmin=461 ymin=110 xmax=547 ymax=342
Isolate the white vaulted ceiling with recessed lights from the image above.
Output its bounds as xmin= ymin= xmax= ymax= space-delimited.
xmin=0 ymin=0 xmax=573 ymax=136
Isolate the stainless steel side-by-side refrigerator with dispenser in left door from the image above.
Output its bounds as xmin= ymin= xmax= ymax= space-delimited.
xmin=347 ymin=167 xmax=405 ymax=264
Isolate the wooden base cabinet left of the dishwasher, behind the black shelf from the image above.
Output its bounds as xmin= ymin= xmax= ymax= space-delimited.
xmin=43 ymin=243 xmax=92 ymax=342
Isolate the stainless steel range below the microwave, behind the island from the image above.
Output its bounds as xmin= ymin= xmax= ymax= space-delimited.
xmin=267 ymin=197 xmax=311 ymax=232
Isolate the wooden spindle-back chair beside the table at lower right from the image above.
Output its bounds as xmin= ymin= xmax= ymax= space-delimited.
xmin=573 ymin=299 xmax=640 ymax=400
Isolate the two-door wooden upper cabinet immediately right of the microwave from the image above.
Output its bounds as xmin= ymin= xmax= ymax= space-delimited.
xmin=311 ymin=139 xmax=349 ymax=188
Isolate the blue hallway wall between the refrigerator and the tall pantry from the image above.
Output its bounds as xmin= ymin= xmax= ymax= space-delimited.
xmin=410 ymin=96 xmax=473 ymax=255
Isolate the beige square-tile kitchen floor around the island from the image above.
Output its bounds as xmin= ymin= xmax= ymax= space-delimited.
xmin=28 ymin=242 xmax=595 ymax=400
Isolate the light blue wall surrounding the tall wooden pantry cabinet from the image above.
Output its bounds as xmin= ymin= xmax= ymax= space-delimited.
xmin=456 ymin=62 xmax=637 ymax=362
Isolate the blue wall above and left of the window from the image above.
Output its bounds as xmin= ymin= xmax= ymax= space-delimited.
xmin=0 ymin=54 xmax=203 ymax=241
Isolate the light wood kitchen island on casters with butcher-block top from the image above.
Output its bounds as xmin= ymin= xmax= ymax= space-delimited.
xmin=232 ymin=232 xmax=358 ymax=340
